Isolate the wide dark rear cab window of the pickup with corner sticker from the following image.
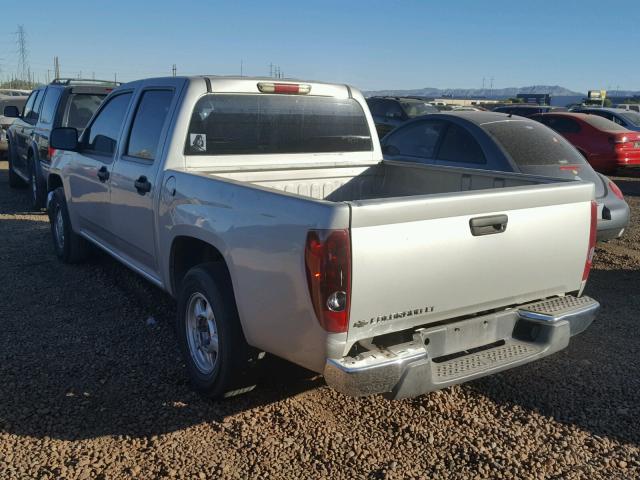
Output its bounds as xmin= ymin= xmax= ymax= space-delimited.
xmin=185 ymin=94 xmax=373 ymax=155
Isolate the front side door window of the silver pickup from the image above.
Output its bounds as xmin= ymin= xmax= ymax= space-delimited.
xmin=84 ymin=93 xmax=131 ymax=156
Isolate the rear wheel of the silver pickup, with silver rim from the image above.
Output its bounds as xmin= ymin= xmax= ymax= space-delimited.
xmin=176 ymin=263 xmax=255 ymax=399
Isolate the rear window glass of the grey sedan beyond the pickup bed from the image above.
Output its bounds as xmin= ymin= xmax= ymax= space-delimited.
xmin=481 ymin=121 xmax=585 ymax=167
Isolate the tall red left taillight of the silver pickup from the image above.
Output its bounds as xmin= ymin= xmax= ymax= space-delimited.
xmin=305 ymin=230 xmax=351 ymax=333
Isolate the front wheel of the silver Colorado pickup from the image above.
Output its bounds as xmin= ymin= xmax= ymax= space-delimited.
xmin=48 ymin=187 xmax=89 ymax=263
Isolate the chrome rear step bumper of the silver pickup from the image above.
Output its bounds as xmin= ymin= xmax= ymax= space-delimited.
xmin=324 ymin=296 xmax=600 ymax=399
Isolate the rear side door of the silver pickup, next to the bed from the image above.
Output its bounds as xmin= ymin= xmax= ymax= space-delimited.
xmin=110 ymin=87 xmax=176 ymax=278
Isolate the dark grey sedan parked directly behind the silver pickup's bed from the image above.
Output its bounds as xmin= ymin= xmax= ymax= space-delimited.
xmin=382 ymin=112 xmax=629 ymax=241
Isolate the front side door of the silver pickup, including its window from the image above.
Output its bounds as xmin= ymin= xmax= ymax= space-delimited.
xmin=67 ymin=91 xmax=132 ymax=246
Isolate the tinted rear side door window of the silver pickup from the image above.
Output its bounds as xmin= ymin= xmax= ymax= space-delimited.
xmin=127 ymin=90 xmax=173 ymax=160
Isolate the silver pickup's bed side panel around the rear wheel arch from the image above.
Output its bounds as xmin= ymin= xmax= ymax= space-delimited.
xmin=159 ymin=170 xmax=349 ymax=371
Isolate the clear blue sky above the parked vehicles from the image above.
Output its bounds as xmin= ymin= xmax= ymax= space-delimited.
xmin=0 ymin=0 xmax=640 ymax=91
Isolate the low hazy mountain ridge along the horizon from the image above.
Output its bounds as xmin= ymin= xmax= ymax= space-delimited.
xmin=364 ymin=85 xmax=588 ymax=98
